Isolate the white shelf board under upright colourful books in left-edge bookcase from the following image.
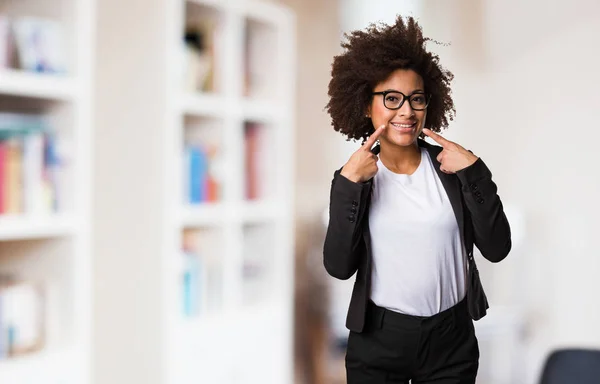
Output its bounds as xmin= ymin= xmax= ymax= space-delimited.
xmin=0 ymin=214 xmax=76 ymax=240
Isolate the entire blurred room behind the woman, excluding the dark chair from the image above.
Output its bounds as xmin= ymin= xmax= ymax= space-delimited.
xmin=0 ymin=0 xmax=600 ymax=384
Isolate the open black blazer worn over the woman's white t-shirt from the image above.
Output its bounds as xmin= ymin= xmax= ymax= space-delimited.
xmin=323 ymin=139 xmax=511 ymax=332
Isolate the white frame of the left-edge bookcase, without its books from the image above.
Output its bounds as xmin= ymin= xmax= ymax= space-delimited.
xmin=0 ymin=0 xmax=94 ymax=384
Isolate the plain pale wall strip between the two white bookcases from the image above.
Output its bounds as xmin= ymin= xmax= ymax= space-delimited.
xmin=93 ymin=0 xmax=166 ymax=384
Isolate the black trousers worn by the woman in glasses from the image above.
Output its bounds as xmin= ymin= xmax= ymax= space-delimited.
xmin=346 ymin=300 xmax=479 ymax=384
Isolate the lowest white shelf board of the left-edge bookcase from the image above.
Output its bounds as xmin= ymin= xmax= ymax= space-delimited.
xmin=0 ymin=350 xmax=82 ymax=384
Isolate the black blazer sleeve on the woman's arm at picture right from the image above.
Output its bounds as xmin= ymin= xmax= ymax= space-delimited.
xmin=456 ymin=158 xmax=512 ymax=263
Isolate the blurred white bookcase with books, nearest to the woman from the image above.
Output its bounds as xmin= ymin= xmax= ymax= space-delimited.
xmin=163 ymin=0 xmax=295 ymax=384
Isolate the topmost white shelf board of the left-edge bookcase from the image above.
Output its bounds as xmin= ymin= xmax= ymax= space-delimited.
xmin=0 ymin=70 xmax=77 ymax=101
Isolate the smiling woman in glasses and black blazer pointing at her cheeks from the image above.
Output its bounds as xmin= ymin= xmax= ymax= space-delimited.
xmin=324 ymin=17 xmax=511 ymax=384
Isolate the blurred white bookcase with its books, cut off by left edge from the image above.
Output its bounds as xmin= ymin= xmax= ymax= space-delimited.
xmin=0 ymin=0 xmax=93 ymax=384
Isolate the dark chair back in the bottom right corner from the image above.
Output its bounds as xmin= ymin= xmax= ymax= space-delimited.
xmin=540 ymin=349 xmax=600 ymax=384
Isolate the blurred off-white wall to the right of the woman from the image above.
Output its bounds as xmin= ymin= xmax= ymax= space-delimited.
xmin=341 ymin=0 xmax=600 ymax=383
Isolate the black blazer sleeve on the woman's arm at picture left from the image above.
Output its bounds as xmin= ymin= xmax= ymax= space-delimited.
xmin=323 ymin=169 xmax=371 ymax=280
